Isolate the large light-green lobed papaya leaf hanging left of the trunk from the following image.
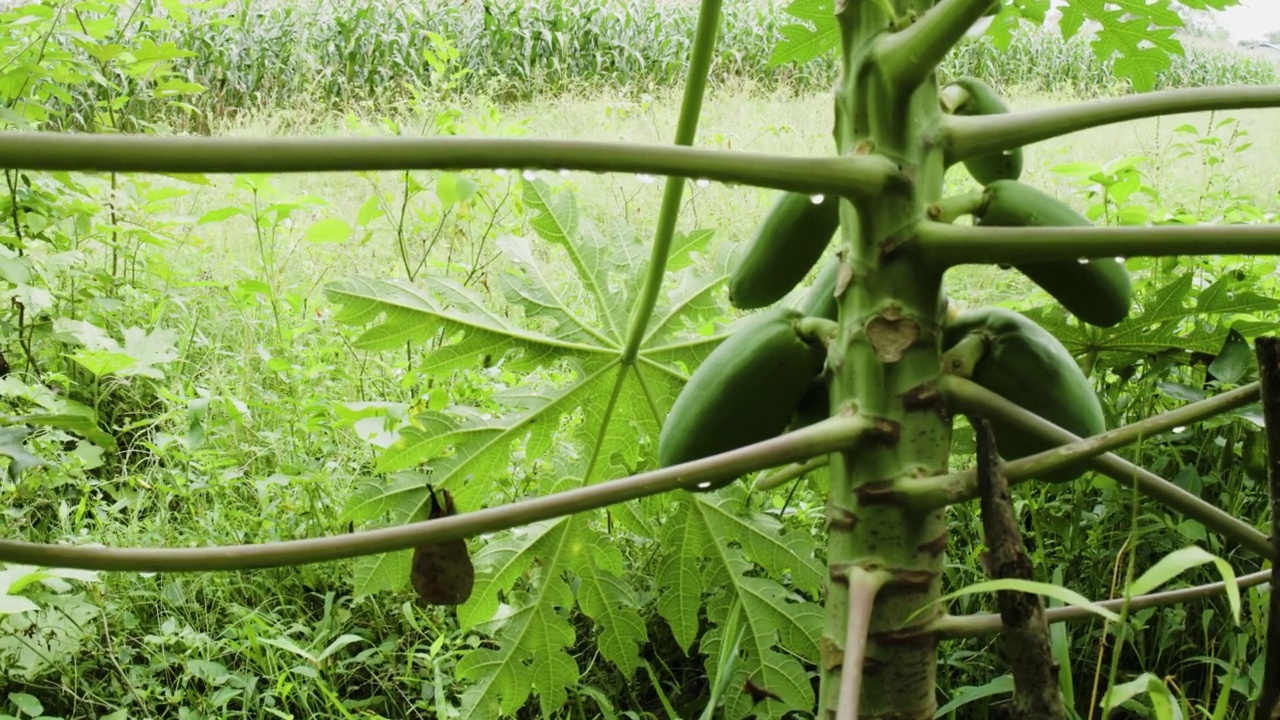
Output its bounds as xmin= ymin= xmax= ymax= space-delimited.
xmin=326 ymin=179 xmax=742 ymax=717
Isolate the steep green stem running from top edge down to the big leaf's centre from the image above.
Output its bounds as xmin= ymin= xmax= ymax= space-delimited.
xmin=622 ymin=0 xmax=721 ymax=365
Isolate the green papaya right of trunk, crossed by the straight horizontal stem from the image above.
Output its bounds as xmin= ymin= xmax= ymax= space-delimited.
xmin=974 ymin=181 xmax=1133 ymax=328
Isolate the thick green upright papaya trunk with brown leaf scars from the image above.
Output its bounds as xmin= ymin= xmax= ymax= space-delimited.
xmin=819 ymin=0 xmax=951 ymax=720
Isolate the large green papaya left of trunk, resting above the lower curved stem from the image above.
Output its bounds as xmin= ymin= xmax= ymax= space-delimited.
xmin=658 ymin=307 xmax=827 ymax=491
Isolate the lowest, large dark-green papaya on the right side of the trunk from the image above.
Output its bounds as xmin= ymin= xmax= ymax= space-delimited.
xmin=942 ymin=307 xmax=1106 ymax=482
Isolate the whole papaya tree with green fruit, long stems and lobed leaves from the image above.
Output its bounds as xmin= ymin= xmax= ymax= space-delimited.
xmin=0 ymin=0 xmax=1280 ymax=720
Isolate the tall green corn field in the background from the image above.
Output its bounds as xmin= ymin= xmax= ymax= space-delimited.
xmin=6 ymin=0 xmax=1276 ymax=132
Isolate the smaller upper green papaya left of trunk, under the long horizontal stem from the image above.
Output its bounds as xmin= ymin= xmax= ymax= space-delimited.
xmin=728 ymin=192 xmax=840 ymax=310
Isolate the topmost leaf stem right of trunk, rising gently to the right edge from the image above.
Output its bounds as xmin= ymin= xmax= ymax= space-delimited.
xmin=937 ymin=86 xmax=1280 ymax=165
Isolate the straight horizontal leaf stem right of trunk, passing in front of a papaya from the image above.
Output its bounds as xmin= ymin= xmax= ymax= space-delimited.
xmin=911 ymin=220 xmax=1280 ymax=268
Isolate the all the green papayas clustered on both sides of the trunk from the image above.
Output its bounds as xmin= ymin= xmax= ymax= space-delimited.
xmin=658 ymin=78 xmax=1132 ymax=491
